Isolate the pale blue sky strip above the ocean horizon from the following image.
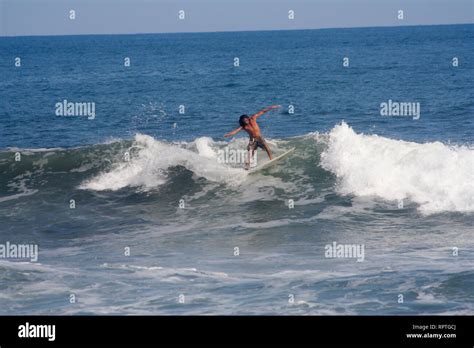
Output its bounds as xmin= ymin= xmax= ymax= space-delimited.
xmin=0 ymin=0 xmax=474 ymax=36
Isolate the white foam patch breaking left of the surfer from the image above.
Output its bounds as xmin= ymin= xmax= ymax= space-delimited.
xmin=79 ymin=134 xmax=247 ymax=191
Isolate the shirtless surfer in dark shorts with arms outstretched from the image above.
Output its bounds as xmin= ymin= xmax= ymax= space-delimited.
xmin=224 ymin=105 xmax=281 ymax=169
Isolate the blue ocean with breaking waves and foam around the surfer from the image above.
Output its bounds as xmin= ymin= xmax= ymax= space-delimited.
xmin=0 ymin=25 xmax=474 ymax=315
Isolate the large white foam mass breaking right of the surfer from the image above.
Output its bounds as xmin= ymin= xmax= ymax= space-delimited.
xmin=321 ymin=122 xmax=474 ymax=214
